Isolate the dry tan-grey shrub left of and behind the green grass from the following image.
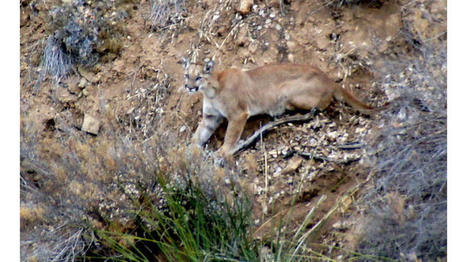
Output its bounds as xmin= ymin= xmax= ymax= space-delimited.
xmin=20 ymin=101 xmax=241 ymax=261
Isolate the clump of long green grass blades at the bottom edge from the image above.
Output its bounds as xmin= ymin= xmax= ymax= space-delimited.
xmin=93 ymin=174 xmax=257 ymax=261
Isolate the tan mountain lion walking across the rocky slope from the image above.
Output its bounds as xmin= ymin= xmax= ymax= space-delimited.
xmin=185 ymin=60 xmax=372 ymax=156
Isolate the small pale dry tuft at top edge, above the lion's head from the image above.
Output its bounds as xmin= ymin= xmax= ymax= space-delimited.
xmin=149 ymin=0 xmax=186 ymax=29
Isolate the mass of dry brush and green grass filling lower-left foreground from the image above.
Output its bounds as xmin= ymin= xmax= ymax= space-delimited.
xmin=21 ymin=119 xmax=330 ymax=261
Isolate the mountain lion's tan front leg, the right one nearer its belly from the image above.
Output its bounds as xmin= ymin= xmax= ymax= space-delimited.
xmin=218 ymin=112 xmax=249 ymax=157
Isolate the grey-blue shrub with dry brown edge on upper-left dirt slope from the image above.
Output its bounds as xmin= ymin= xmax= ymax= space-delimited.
xmin=43 ymin=0 xmax=128 ymax=79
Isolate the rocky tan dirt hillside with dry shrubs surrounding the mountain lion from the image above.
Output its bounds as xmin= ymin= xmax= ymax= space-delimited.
xmin=20 ymin=0 xmax=447 ymax=261
